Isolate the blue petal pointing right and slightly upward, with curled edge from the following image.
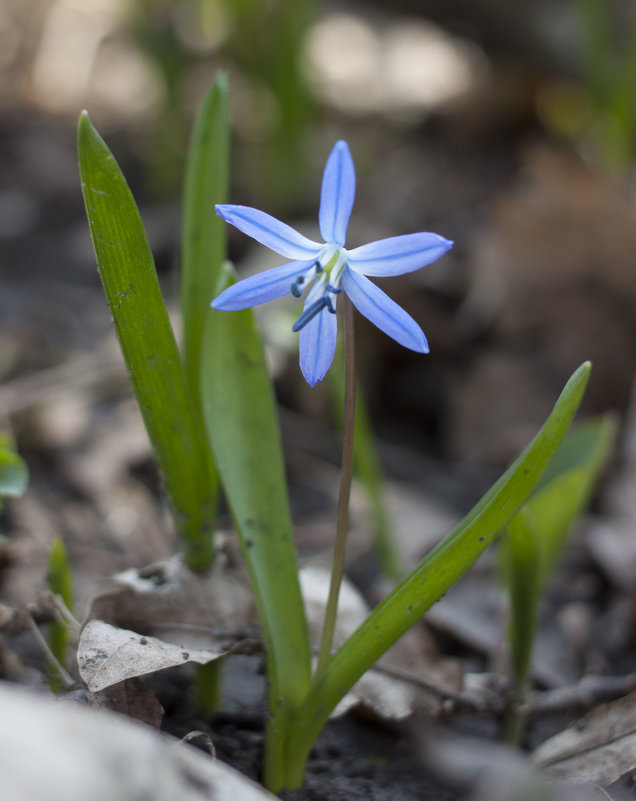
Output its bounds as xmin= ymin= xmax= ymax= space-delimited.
xmin=347 ymin=233 xmax=453 ymax=276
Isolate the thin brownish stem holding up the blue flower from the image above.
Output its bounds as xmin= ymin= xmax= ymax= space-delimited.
xmin=313 ymin=295 xmax=356 ymax=684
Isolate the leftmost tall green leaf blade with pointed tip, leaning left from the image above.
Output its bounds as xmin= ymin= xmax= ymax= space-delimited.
xmin=78 ymin=112 xmax=216 ymax=569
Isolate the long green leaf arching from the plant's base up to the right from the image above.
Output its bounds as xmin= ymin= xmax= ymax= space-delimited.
xmin=287 ymin=362 xmax=590 ymax=786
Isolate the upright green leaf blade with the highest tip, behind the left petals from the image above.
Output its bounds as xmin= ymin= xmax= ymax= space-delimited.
xmin=181 ymin=73 xmax=230 ymax=412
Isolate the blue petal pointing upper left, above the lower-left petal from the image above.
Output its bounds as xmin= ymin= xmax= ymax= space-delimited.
xmin=215 ymin=204 xmax=323 ymax=259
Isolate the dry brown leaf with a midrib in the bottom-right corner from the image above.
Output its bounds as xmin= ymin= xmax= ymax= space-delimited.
xmin=532 ymin=692 xmax=636 ymax=785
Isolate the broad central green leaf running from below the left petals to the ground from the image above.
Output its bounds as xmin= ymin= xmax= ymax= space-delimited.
xmin=201 ymin=268 xmax=310 ymax=788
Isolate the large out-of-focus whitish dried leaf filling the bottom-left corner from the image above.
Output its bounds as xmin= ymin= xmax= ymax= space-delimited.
xmin=0 ymin=684 xmax=274 ymax=801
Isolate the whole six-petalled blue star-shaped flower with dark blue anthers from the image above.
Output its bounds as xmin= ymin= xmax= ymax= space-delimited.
xmin=212 ymin=141 xmax=453 ymax=386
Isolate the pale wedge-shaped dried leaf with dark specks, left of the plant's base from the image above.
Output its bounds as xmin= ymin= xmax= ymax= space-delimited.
xmin=77 ymin=620 xmax=256 ymax=692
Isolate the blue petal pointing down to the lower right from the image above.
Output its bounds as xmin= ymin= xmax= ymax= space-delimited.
xmin=342 ymin=268 xmax=428 ymax=353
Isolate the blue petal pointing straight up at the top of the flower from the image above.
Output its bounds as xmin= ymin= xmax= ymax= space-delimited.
xmin=318 ymin=140 xmax=356 ymax=246
